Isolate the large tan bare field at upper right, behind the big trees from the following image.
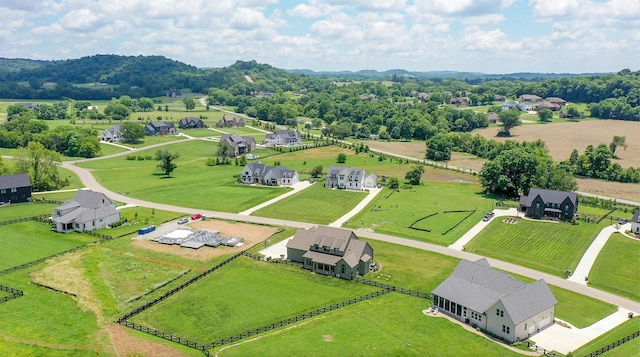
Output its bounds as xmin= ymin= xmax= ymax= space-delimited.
xmin=472 ymin=120 xmax=640 ymax=167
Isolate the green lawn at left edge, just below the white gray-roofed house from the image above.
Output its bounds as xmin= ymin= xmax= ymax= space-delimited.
xmin=0 ymin=221 xmax=97 ymax=270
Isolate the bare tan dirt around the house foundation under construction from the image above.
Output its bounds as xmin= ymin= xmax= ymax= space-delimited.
xmin=132 ymin=220 xmax=278 ymax=261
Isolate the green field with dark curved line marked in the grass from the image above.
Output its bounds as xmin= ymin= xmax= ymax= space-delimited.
xmin=346 ymin=181 xmax=495 ymax=246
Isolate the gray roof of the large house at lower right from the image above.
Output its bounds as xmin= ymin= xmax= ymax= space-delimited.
xmin=433 ymin=259 xmax=558 ymax=318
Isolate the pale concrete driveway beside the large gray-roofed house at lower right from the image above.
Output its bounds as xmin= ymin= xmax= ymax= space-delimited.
xmin=531 ymin=308 xmax=630 ymax=355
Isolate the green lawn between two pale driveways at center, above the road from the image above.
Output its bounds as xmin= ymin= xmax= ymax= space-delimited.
xmin=253 ymin=182 xmax=367 ymax=224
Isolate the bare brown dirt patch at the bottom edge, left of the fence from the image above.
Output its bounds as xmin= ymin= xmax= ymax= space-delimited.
xmin=106 ymin=324 xmax=188 ymax=357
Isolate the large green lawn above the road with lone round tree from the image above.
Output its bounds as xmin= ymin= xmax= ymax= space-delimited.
xmin=79 ymin=140 xmax=287 ymax=212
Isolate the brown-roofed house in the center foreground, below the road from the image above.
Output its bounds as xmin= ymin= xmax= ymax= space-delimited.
xmin=287 ymin=226 xmax=373 ymax=280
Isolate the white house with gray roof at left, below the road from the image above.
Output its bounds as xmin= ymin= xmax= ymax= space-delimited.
xmin=51 ymin=190 xmax=120 ymax=233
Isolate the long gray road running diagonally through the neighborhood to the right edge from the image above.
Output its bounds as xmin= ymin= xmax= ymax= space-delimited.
xmin=62 ymin=160 xmax=640 ymax=313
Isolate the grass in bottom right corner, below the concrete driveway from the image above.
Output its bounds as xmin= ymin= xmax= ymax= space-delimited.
xmin=573 ymin=317 xmax=640 ymax=357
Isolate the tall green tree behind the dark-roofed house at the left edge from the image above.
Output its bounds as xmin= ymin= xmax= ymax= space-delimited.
xmin=16 ymin=141 xmax=64 ymax=191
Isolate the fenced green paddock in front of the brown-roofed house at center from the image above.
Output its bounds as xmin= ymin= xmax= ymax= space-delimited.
xmin=132 ymin=257 xmax=377 ymax=343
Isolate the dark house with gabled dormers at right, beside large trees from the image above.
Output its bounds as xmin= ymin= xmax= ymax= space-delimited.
xmin=520 ymin=188 xmax=578 ymax=221
